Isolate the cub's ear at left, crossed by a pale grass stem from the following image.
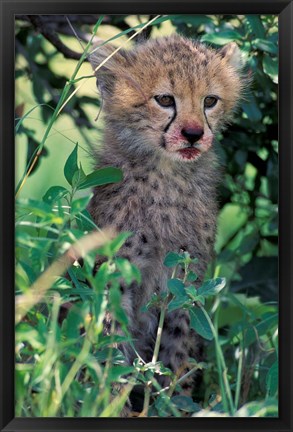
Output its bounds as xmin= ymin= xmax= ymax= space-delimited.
xmin=89 ymin=44 xmax=131 ymax=94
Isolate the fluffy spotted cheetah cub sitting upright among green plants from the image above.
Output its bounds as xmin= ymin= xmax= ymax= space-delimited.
xmin=89 ymin=35 xmax=245 ymax=400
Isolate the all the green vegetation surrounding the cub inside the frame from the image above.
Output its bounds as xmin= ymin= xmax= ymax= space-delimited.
xmin=16 ymin=15 xmax=278 ymax=417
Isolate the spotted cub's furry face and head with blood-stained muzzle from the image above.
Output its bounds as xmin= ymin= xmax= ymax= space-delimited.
xmin=90 ymin=36 xmax=245 ymax=163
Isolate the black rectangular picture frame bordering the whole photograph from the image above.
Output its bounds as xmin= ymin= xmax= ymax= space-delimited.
xmin=0 ymin=0 xmax=293 ymax=432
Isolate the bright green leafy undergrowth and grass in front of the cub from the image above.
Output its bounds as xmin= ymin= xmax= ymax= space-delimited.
xmin=16 ymin=146 xmax=278 ymax=417
